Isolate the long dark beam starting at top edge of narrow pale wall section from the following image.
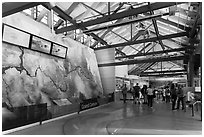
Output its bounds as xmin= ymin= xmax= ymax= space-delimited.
xmin=95 ymin=32 xmax=188 ymax=50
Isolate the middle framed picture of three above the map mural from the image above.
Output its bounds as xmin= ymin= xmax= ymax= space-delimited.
xmin=31 ymin=36 xmax=51 ymax=53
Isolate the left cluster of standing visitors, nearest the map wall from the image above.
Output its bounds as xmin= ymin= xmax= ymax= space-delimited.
xmin=121 ymin=83 xmax=155 ymax=107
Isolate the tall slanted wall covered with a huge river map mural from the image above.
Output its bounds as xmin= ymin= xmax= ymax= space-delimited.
xmin=2 ymin=13 xmax=103 ymax=107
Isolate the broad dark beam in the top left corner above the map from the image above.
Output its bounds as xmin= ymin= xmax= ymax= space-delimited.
xmin=2 ymin=2 xmax=42 ymax=17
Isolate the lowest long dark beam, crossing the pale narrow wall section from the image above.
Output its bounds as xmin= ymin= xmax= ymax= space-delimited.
xmin=98 ymin=56 xmax=187 ymax=67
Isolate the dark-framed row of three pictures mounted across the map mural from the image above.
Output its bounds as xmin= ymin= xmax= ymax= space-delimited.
xmin=2 ymin=24 xmax=68 ymax=59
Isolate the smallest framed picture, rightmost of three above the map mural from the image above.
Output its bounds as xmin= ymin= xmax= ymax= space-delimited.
xmin=51 ymin=43 xmax=67 ymax=58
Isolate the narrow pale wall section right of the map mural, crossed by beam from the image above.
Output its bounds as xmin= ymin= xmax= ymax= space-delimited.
xmin=95 ymin=48 xmax=115 ymax=94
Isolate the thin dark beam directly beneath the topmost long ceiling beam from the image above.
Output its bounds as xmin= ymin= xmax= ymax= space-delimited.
xmin=84 ymin=13 xmax=169 ymax=33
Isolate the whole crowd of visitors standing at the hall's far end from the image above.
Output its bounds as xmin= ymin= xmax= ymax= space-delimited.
xmin=121 ymin=83 xmax=185 ymax=110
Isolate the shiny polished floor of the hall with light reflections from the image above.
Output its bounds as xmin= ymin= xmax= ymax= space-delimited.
xmin=5 ymin=101 xmax=202 ymax=135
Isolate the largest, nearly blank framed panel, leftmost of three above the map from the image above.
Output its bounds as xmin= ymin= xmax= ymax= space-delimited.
xmin=2 ymin=25 xmax=30 ymax=48
